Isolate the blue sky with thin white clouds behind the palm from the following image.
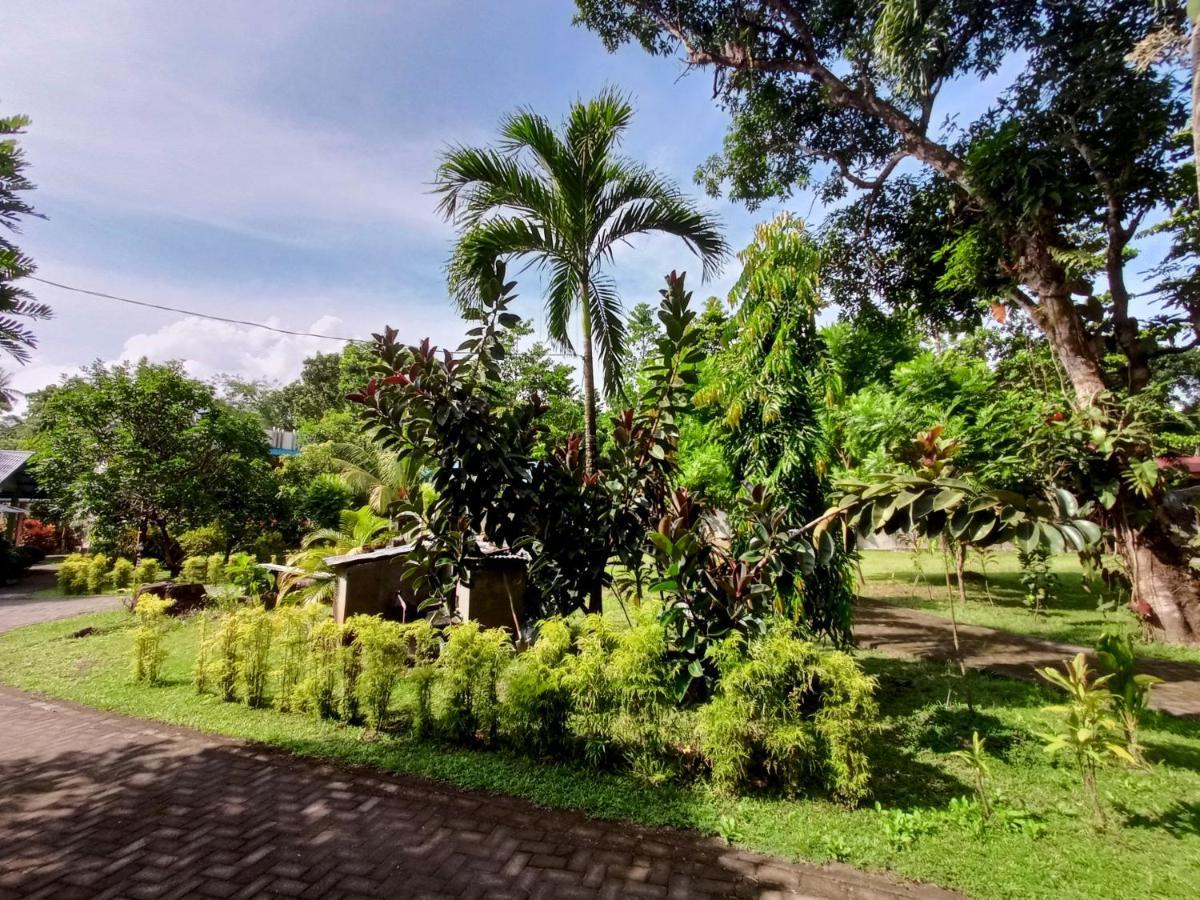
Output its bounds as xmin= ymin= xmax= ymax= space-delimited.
xmin=7 ymin=0 xmax=1171 ymax=391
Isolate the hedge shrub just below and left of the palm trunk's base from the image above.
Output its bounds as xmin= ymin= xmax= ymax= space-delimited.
xmin=500 ymin=617 xmax=571 ymax=754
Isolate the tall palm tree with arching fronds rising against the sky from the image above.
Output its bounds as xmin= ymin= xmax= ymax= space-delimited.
xmin=436 ymin=91 xmax=728 ymax=472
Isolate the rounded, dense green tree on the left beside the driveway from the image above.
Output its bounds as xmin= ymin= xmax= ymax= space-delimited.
xmin=32 ymin=360 xmax=275 ymax=572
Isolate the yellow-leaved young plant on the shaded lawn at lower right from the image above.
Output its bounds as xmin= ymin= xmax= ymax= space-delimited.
xmin=1038 ymin=653 xmax=1135 ymax=827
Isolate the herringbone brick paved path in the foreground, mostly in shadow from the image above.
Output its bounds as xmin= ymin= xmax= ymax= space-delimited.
xmin=0 ymin=688 xmax=953 ymax=900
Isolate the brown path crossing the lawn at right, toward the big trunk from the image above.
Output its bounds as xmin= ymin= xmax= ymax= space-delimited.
xmin=854 ymin=598 xmax=1200 ymax=719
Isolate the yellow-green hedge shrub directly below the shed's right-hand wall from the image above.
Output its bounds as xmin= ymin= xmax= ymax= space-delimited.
xmin=438 ymin=622 xmax=512 ymax=742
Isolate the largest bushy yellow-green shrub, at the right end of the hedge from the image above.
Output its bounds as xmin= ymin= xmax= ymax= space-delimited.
xmin=700 ymin=620 xmax=878 ymax=800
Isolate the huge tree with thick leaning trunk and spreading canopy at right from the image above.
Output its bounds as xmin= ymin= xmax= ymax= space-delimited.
xmin=578 ymin=0 xmax=1200 ymax=642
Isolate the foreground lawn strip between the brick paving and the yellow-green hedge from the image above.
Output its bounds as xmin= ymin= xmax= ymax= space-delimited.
xmin=0 ymin=612 xmax=1200 ymax=898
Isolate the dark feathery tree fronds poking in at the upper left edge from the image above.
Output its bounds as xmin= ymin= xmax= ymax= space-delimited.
xmin=0 ymin=115 xmax=50 ymax=381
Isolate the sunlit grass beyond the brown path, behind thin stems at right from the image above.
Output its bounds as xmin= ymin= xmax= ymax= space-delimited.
xmin=859 ymin=550 xmax=1200 ymax=662
